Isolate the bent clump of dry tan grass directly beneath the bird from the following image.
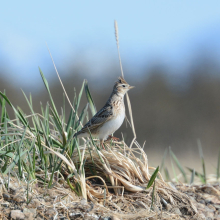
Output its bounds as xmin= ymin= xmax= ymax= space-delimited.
xmin=70 ymin=143 xmax=197 ymax=213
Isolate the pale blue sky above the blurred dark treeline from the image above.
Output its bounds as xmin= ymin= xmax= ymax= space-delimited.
xmin=0 ymin=0 xmax=220 ymax=88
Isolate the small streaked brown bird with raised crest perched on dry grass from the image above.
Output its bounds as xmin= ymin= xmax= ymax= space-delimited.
xmin=73 ymin=77 xmax=134 ymax=149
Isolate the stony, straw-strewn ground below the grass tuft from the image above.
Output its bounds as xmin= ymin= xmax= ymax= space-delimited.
xmin=0 ymin=182 xmax=220 ymax=220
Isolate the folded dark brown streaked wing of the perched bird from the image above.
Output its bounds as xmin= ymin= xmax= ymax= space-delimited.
xmin=76 ymin=104 xmax=113 ymax=135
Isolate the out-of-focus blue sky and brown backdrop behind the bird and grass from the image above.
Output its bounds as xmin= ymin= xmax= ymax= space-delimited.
xmin=0 ymin=0 xmax=220 ymax=173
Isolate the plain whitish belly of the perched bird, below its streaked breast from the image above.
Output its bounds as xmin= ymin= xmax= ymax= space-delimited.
xmin=98 ymin=111 xmax=125 ymax=140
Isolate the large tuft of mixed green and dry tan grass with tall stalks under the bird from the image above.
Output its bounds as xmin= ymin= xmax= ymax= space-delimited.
xmin=0 ymin=22 xmax=205 ymax=219
